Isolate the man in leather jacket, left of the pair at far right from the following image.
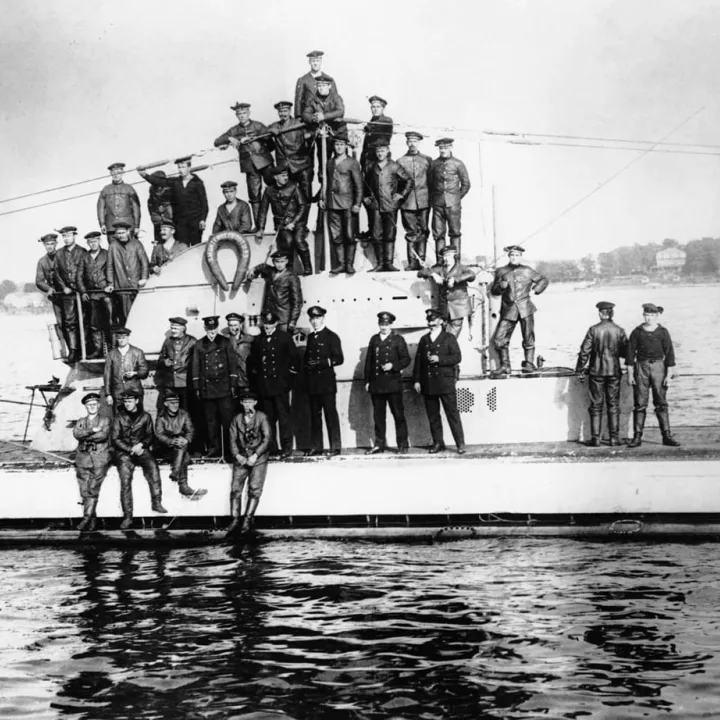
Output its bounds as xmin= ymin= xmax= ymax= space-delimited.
xmin=575 ymin=301 xmax=627 ymax=447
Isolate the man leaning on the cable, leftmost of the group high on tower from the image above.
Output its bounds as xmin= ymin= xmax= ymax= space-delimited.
xmin=214 ymin=103 xmax=273 ymax=232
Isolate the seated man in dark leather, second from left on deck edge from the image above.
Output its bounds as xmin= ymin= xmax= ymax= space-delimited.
xmin=111 ymin=390 xmax=167 ymax=530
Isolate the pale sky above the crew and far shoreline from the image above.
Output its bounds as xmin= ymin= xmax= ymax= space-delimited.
xmin=0 ymin=0 xmax=720 ymax=280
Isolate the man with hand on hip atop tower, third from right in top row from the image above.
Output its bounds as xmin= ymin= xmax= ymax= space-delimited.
xmin=363 ymin=143 xmax=413 ymax=272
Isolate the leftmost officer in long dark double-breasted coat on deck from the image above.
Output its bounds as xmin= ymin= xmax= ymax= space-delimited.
xmin=191 ymin=315 xmax=237 ymax=458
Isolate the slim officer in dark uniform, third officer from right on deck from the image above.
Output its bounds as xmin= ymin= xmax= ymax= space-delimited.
xmin=304 ymin=305 xmax=344 ymax=456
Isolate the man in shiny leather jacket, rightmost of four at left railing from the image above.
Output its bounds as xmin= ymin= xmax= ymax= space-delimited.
xmin=105 ymin=220 xmax=150 ymax=325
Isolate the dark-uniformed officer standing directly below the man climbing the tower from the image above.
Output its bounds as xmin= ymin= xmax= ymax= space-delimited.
xmin=248 ymin=312 xmax=298 ymax=459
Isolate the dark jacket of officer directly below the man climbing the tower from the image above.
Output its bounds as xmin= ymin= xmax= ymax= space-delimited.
xmin=248 ymin=330 xmax=298 ymax=397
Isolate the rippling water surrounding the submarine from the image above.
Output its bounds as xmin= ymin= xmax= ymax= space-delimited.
xmin=0 ymin=287 xmax=720 ymax=720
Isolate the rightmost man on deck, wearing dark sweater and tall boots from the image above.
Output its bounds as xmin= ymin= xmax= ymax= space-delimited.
xmin=626 ymin=303 xmax=680 ymax=447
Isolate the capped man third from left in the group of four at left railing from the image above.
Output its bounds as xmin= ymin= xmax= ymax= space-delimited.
xmin=77 ymin=230 xmax=112 ymax=359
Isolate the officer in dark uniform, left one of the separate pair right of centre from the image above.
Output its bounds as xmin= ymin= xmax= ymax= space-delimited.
xmin=364 ymin=312 xmax=410 ymax=455
